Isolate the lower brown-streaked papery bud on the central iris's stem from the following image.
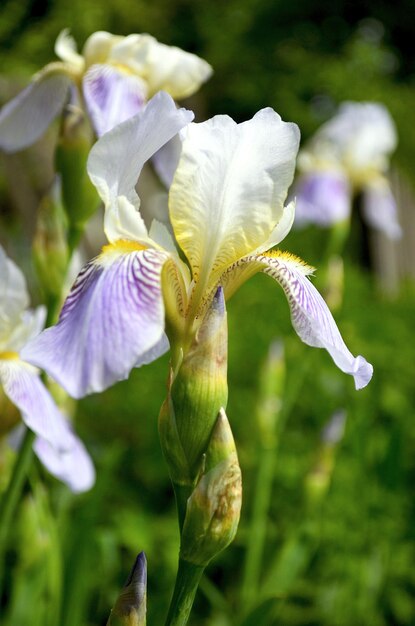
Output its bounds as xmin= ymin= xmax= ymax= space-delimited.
xmin=180 ymin=409 xmax=242 ymax=567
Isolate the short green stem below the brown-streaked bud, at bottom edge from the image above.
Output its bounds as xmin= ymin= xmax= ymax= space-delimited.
xmin=165 ymin=559 xmax=204 ymax=626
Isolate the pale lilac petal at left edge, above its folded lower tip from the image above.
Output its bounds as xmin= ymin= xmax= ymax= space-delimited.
xmin=0 ymin=358 xmax=70 ymax=450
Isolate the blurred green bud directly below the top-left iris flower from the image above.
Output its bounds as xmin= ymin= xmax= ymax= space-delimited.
xmin=55 ymin=106 xmax=100 ymax=243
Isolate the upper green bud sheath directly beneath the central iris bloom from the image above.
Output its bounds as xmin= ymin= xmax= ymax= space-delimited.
xmin=159 ymin=288 xmax=228 ymax=483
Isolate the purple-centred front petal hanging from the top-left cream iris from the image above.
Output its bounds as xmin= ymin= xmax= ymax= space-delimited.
xmin=82 ymin=65 xmax=147 ymax=137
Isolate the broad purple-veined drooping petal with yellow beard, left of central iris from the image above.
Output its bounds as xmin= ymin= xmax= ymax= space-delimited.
xmin=22 ymin=242 xmax=166 ymax=398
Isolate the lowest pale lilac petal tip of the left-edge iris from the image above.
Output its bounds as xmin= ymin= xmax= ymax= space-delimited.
xmin=33 ymin=422 xmax=95 ymax=493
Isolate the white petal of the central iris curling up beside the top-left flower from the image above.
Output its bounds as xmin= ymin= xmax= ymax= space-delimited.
xmin=87 ymin=92 xmax=193 ymax=242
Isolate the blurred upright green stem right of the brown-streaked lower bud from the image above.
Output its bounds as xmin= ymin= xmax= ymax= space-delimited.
xmin=241 ymin=447 xmax=276 ymax=610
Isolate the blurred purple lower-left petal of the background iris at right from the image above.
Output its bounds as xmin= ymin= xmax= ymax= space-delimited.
xmin=295 ymin=170 xmax=351 ymax=227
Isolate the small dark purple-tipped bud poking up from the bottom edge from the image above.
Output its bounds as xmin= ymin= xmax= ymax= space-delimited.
xmin=107 ymin=552 xmax=147 ymax=626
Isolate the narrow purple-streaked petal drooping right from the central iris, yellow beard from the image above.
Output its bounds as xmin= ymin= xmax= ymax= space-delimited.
xmin=256 ymin=253 xmax=373 ymax=389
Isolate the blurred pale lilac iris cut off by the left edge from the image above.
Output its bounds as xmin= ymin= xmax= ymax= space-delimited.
xmin=0 ymin=247 xmax=95 ymax=492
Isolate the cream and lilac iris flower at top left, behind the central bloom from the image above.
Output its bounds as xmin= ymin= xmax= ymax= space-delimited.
xmin=0 ymin=30 xmax=212 ymax=152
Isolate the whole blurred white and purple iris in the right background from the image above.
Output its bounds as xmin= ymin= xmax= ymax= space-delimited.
xmin=296 ymin=102 xmax=401 ymax=239
